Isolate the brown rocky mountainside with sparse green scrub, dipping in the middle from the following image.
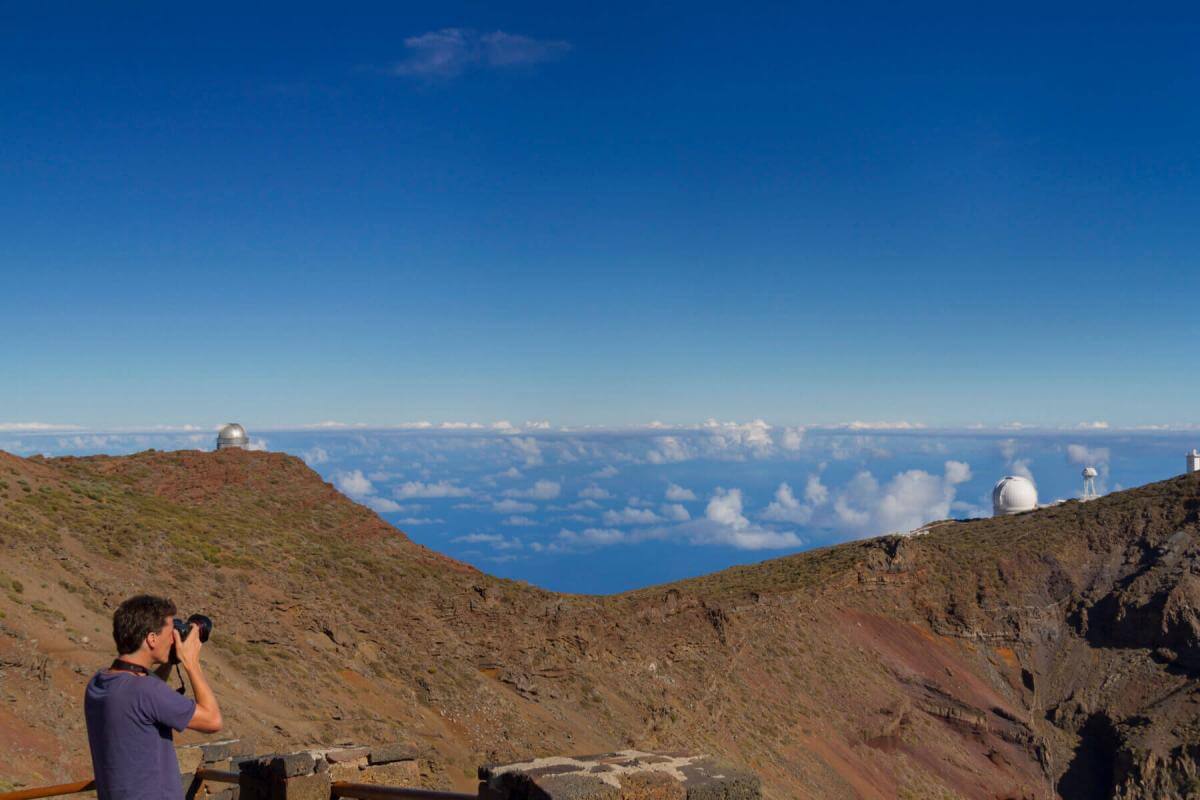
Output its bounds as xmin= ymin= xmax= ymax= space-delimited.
xmin=0 ymin=451 xmax=1200 ymax=800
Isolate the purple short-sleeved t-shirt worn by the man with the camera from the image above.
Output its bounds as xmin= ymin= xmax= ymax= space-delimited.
xmin=83 ymin=669 xmax=196 ymax=800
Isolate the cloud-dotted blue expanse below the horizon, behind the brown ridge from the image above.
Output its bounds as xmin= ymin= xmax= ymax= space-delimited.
xmin=0 ymin=420 xmax=1200 ymax=593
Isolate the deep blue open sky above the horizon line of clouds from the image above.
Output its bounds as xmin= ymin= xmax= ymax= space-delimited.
xmin=0 ymin=2 xmax=1200 ymax=428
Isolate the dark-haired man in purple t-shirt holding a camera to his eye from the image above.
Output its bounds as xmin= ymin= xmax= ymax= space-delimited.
xmin=84 ymin=595 xmax=221 ymax=800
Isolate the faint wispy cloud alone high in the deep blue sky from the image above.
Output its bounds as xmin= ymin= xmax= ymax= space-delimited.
xmin=391 ymin=28 xmax=571 ymax=79
